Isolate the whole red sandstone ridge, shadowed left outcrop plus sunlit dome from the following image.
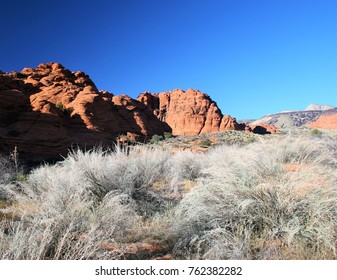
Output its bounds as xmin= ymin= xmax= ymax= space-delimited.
xmin=0 ymin=63 xmax=251 ymax=162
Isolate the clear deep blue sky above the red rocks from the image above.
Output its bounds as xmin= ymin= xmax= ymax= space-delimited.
xmin=0 ymin=0 xmax=337 ymax=119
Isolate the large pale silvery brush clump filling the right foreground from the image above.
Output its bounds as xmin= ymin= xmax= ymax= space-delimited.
xmin=174 ymin=135 xmax=337 ymax=259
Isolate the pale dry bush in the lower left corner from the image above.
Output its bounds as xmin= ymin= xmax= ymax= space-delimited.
xmin=0 ymin=162 xmax=121 ymax=259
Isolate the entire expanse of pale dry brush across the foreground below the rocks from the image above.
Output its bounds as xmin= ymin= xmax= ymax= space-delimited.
xmin=0 ymin=132 xmax=337 ymax=259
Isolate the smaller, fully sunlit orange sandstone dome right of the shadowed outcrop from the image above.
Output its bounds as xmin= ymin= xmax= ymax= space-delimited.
xmin=137 ymin=89 xmax=246 ymax=136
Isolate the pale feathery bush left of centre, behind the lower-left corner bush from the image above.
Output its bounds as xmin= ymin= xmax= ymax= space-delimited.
xmin=65 ymin=146 xmax=175 ymax=215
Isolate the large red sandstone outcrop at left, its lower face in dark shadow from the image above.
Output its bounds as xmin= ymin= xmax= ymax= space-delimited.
xmin=0 ymin=63 xmax=170 ymax=161
